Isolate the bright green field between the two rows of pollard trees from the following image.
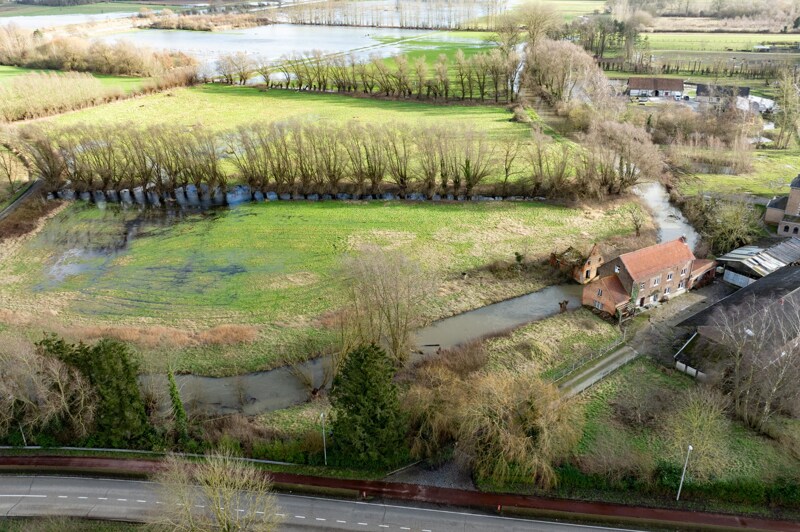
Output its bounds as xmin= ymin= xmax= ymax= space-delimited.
xmin=47 ymin=84 xmax=529 ymax=136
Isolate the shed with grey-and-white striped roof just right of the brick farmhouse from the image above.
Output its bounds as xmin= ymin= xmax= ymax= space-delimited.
xmin=717 ymin=238 xmax=800 ymax=287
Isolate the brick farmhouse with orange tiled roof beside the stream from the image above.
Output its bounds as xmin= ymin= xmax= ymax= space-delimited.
xmin=581 ymin=238 xmax=716 ymax=316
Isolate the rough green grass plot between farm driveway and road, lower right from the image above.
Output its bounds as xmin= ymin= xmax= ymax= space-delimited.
xmin=578 ymin=358 xmax=800 ymax=488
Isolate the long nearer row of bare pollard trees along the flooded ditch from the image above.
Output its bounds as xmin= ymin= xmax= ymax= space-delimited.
xmin=7 ymin=117 xmax=662 ymax=199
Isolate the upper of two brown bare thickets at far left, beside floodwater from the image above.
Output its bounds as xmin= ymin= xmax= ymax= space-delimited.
xmin=0 ymin=25 xmax=196 ymax=76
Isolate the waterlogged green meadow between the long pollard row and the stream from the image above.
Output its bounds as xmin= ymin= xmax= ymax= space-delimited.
xmin=0 ymin=200 xmax=632 ymax=375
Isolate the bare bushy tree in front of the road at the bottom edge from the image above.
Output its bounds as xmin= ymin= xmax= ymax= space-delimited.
xmin=151 ymin=452 xmax=281 ymax=532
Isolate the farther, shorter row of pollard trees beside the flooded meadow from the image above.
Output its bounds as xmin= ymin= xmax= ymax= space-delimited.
xmin=217 ymin=49 xmax=521 ymax=102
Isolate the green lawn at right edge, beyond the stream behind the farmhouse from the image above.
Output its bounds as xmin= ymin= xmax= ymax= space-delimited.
xmin=680 ymin=149 xmax=800 ymax=198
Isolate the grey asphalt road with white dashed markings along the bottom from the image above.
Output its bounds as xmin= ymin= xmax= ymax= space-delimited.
xmin=0 ymin=476 xmax=636 ymax=532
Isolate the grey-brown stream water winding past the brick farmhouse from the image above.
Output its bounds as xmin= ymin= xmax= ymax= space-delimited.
xmin=131 ymin=183 xmax=700 ymax=415
